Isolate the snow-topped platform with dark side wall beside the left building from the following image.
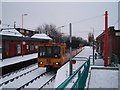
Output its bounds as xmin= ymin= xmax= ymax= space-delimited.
xmin=0 ymin=53 xmax=37 ymax=76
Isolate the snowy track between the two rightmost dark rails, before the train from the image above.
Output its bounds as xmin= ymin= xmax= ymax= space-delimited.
xmin=17 ymin=71 xmax=56 ymax=90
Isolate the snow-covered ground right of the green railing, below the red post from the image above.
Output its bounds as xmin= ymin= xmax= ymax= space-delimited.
xmin=88 ymin=59 xmax=120 ymax=90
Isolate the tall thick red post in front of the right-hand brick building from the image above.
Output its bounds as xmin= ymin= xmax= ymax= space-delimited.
xmin=104 ymin=11 xmax=108 ymax=66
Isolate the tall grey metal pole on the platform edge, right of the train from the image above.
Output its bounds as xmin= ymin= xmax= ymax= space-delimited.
xmin=69 ymin=23 xmax=73 ymax=76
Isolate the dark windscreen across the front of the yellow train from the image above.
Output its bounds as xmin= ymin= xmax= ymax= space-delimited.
xmin=38 ymin=46 xmax=60 ymax=58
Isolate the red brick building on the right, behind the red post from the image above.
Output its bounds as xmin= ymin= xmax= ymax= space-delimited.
xmin=96 ymin=27 xmax=120 ymax=63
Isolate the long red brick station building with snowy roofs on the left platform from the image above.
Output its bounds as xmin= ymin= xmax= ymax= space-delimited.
xmin=0 ymin=28 xmax=52 ymax=59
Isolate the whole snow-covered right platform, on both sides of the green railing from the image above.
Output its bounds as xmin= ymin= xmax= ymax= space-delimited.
xmin=54 ymin=47 xmax=120 ymax=90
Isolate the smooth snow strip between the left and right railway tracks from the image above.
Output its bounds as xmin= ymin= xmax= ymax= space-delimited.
xmin=2 ymin=68 xmax=46 ymax=89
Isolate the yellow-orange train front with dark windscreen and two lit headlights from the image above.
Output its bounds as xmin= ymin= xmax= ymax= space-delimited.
xmin=38 ymin=44 xmax=66 ymax=69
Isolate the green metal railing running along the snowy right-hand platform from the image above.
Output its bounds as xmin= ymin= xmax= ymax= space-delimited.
xmin=56 ymin=56 xmax=91 ymax=90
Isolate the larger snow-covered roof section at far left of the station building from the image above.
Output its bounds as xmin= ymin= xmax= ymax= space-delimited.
xmin=0 ymin=29 xmax=24 ymax=37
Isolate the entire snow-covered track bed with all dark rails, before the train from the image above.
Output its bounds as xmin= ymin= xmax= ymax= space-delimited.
xmin=0 ymin=62 xmax=55 ymax=90
